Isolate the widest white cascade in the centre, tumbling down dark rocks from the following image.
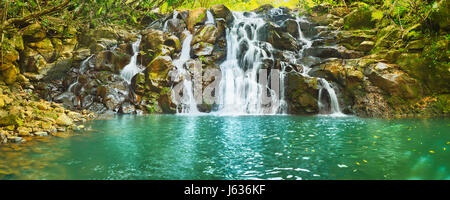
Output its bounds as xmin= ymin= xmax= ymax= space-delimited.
xmin=216 ymin=12 xmax=278 ymax=115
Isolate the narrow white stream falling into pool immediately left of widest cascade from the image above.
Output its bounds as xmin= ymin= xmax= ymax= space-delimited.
xmin=172 ymin=30 xmax=199 ymax=113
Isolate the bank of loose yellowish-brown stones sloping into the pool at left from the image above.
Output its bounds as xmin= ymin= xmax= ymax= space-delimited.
xmin=0 ymin=83 xmax=96 ymax=143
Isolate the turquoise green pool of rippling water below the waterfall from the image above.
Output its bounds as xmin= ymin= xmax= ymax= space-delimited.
xmin=0 ymin=115 xmax=450 ymax=180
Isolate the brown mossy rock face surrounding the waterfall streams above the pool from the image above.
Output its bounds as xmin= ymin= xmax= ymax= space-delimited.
xmin=0 ymin=3 xmax=450 ymax=122
